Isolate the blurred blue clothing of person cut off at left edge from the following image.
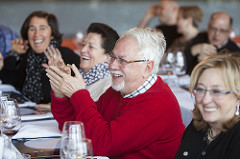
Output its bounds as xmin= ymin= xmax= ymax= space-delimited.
xmin=0 ymin=24 xmax=19 ymax=58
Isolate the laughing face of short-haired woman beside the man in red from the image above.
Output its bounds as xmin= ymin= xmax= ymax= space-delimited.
xmin=80 ymin=33 xmax=107 ymax=73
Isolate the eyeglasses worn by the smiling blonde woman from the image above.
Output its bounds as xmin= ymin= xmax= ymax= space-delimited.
xmin=193 ymin=87 xmax=234 ymax=99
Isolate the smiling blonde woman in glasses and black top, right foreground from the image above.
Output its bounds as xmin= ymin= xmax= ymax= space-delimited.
xmin=175 ymin=54 xmax=240 ymax=159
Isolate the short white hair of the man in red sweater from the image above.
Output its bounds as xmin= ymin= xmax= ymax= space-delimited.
xmin=120 ymin=28 xmax=166 ymax=74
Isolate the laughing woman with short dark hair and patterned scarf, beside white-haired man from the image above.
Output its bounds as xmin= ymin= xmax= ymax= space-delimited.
xmin=36 ymin=23 xmax=119 ymax=111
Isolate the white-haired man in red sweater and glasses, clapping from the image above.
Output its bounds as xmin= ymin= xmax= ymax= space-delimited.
xmin=46 ymin=28 xmax=184 ymax=159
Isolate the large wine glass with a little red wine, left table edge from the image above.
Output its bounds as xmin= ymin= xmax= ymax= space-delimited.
xmin=0 ymin=98 xmax=21 ymax=149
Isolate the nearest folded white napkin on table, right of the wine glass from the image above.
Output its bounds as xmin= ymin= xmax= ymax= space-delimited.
xmin=13 ymin=125 xmax=61 ymax=139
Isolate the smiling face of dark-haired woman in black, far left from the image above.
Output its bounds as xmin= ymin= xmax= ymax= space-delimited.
xmin=28 ymin=17 xmax=53 ymax=53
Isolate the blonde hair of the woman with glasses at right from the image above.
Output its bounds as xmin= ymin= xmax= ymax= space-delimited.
xmin=189 ymin=53 xmax=240 ymax=132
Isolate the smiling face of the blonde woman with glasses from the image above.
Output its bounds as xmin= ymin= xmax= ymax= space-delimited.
xmin=196 ymin=68 xmax=238 ymax=125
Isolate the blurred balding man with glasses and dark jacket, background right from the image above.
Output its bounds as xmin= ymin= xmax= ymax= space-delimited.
xmin=185 ymin=12 xmax=240 ymax=74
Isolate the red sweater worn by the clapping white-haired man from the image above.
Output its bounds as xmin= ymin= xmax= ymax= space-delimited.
xmin=51 ymin=78 xmax=185 ymax=159
